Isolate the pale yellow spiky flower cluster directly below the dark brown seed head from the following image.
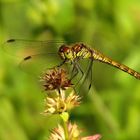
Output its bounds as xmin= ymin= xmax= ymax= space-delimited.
xmin=43 ymin=91 xmax=81 ymax=114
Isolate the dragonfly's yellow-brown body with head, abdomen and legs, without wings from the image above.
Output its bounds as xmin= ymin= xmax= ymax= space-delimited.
xmin=58 ymin=43 xmax=140 ymax=89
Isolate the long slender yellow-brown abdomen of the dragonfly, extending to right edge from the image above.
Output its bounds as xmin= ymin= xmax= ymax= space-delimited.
xmin=93 ymin=52 xmax=140 ymax=79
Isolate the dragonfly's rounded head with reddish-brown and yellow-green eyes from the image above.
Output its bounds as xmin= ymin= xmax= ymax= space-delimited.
xmin=59 ymin=45 xmax=73 ymax=60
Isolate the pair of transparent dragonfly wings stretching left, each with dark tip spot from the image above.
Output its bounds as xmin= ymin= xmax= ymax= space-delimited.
xmin=3 ymin=39 xmax=64 ymax=76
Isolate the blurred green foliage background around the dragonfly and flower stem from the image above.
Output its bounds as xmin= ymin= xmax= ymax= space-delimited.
xmin=0 ymin=0 xmax=140 ymax=140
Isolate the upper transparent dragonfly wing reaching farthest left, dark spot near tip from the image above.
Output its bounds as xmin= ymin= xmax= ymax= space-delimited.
xmin=3 ymin=39 xmax=64 ymax=58
